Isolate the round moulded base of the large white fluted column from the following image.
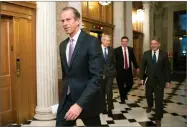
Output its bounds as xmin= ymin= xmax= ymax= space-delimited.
xmin=34 ymin=107 xmax=56 ymax=120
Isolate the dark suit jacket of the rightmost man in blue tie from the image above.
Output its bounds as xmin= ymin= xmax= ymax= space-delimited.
xmin=140 ymin=50 xmax=170 ymax=87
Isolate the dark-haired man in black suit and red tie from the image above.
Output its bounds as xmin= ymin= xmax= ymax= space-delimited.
xmin=114 ymin=36 xmax=139 ymax=103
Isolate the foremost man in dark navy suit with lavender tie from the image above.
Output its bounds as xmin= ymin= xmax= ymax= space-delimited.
xmin=56 ymin=7 xmax=104 ymax=126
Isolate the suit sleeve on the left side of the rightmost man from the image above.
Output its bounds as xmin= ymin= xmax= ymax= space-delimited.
xmin=140 ymin=53 xmax=147 ymax=80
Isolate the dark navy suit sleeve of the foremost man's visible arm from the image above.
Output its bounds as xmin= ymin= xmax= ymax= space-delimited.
xmin=76 ymin=38 xmax=104 ymax=109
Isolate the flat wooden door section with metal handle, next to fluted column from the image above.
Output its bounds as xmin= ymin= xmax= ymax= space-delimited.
xmin=13 ymin=17 xmax=36 ymax=122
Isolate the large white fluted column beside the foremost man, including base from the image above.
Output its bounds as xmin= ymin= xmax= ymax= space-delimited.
xmin=34 ymin=2 xmax=58 ymax=120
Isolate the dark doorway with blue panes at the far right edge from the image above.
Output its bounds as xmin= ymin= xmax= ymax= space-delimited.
xmin=173 ymin=10 xmax=187 ymax=72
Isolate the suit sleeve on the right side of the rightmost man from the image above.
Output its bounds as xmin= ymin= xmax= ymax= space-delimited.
xmin=165 ymin=53 xmax=171 ymax=82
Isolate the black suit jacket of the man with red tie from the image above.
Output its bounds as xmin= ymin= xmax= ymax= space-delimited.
xmin=114 ymin=46 xmax=138 ymax=72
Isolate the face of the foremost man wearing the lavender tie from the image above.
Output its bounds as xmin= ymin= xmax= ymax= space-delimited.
xmin=61 ymin=10 xmax=79 ymax=37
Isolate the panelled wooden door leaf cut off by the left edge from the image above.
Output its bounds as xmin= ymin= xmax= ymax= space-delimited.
xmin=0 ymin=17 xmax=14 ymax=125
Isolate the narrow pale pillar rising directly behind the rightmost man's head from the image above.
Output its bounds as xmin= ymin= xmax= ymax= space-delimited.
xmin=143 ymin=2 xmax=150 ymax=52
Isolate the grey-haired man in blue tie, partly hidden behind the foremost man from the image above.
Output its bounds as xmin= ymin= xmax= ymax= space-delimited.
xmin=101 ymin=33 xmax=116 ymax=117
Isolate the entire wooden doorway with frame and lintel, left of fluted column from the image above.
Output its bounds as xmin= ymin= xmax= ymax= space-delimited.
xmin=0 ymin=2 xmax=36 ymax=125
